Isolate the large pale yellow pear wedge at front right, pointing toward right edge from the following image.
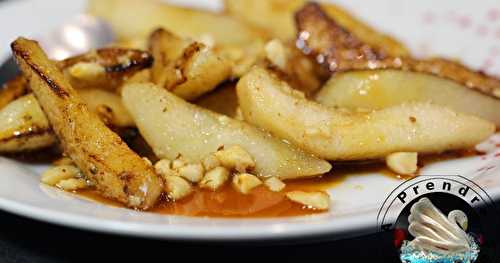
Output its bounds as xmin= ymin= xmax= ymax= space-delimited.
xmin=237 ymin=68 xmax=495 ymax=160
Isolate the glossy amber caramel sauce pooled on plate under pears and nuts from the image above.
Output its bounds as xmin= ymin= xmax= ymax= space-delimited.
xmin=77 ymin=151 xmax=477 ymax=218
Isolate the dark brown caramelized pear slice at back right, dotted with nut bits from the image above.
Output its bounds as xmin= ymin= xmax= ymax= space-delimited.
xmin=296 ymin=3 xmax=500 ymax=98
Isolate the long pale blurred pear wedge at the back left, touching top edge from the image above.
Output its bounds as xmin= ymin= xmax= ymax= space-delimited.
xmin=88 ymin=0 xmax=263 ymax=45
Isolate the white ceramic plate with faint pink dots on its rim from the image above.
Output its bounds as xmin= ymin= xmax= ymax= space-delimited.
xmin=0 ymin=0 xmax=500 ymax=241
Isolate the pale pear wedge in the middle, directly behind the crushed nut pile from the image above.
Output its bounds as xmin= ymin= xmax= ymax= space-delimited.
xmin=122 ymin=84 xmax=331 ymax=179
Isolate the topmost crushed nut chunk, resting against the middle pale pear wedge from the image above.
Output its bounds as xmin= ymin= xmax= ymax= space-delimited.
xmin=215 ymin=145 xmax=255 ymax=173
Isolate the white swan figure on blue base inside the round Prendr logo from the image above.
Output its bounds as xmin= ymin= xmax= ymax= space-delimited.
xmin=400 ymin=197 xmax=479 ymax=263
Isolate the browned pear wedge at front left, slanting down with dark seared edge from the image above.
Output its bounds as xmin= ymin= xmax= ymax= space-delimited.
xmin=11 ymin=38 xmax=163 ymax=209
